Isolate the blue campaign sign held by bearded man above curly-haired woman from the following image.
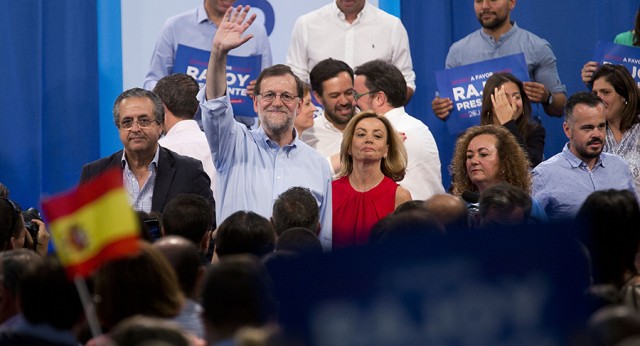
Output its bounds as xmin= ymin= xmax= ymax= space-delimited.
xmin=435 ymin=53 xmax=529 ymax=135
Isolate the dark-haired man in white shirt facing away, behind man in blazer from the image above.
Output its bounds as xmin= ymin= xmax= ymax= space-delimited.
xmin=153 ymin=73 xmax=216 ymax=195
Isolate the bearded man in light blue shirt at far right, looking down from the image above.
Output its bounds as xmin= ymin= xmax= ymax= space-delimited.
xmin=532 ymin=92 xmax=635 ymax=221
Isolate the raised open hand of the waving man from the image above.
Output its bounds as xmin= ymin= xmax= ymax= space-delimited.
xmin=213 ymin=5 xmax=256 ymax=54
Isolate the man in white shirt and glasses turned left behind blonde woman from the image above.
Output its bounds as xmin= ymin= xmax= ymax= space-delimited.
xmin=354 ymin=60 xmax=444 ymax=200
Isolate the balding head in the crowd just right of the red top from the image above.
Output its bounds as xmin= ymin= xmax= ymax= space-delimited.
xmin=424 ymin=194 xmax=469 ymax=231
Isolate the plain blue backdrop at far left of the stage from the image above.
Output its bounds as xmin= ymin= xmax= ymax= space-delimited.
xmin=0 ymin=0 xmax=99 ymax=208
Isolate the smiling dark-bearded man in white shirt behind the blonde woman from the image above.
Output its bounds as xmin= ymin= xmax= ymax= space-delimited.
xmin=300 ymin=58 xmax=356 ymax=172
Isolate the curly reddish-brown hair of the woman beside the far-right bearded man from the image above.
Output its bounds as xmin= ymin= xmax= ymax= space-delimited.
xmin=449 ymin=125 xmax=531 ymax=196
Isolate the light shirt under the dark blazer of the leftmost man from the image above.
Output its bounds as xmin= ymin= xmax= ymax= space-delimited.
xmin=122 ymin=147 xmax=160 ymax=213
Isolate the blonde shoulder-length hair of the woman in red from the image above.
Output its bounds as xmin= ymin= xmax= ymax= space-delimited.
xmin=338 ymin=111 xmax=407 ymax=181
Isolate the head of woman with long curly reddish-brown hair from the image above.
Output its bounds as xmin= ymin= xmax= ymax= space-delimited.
xmin=451 ymin=125 xmax=531 ymax=196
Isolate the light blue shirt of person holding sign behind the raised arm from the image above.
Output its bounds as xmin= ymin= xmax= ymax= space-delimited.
xmin=144 ymin=2 xmax=272 ymax=90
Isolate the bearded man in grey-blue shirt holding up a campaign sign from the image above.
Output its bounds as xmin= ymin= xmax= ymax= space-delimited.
xmin=431 ymin=0 xmax=567 ymax=120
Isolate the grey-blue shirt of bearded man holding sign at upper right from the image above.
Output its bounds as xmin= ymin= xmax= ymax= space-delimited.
xmin=445 ymin=22 xmax=566 ymax=93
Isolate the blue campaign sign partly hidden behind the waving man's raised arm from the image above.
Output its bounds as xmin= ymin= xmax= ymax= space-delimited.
xmin=172 ymin=44 xmax=262 ymax=117
